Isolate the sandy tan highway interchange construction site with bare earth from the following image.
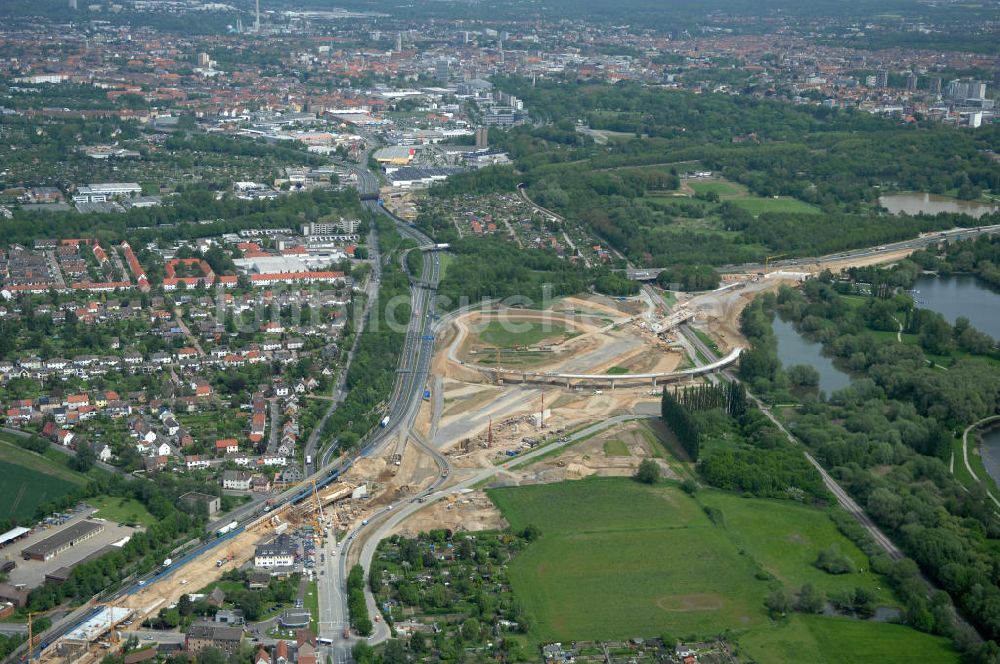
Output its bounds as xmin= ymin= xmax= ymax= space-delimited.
xmin=31 ymin=279 xmax=804 ymax=664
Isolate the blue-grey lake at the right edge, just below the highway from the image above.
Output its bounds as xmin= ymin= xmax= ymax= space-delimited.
xmin=913 ymin=275 xmax=1000 ymax=339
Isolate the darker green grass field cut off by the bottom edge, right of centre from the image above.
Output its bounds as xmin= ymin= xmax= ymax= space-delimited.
xmin=739 ymin=615 xmax=959 ymax=664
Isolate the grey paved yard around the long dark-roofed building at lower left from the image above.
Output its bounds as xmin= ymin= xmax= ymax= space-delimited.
xmin=0 ymin=508 xmax=136 ymax=588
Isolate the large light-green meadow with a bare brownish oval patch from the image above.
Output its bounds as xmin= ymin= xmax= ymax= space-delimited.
xmin=489 ymin=478 xmax=769 ymax=642
